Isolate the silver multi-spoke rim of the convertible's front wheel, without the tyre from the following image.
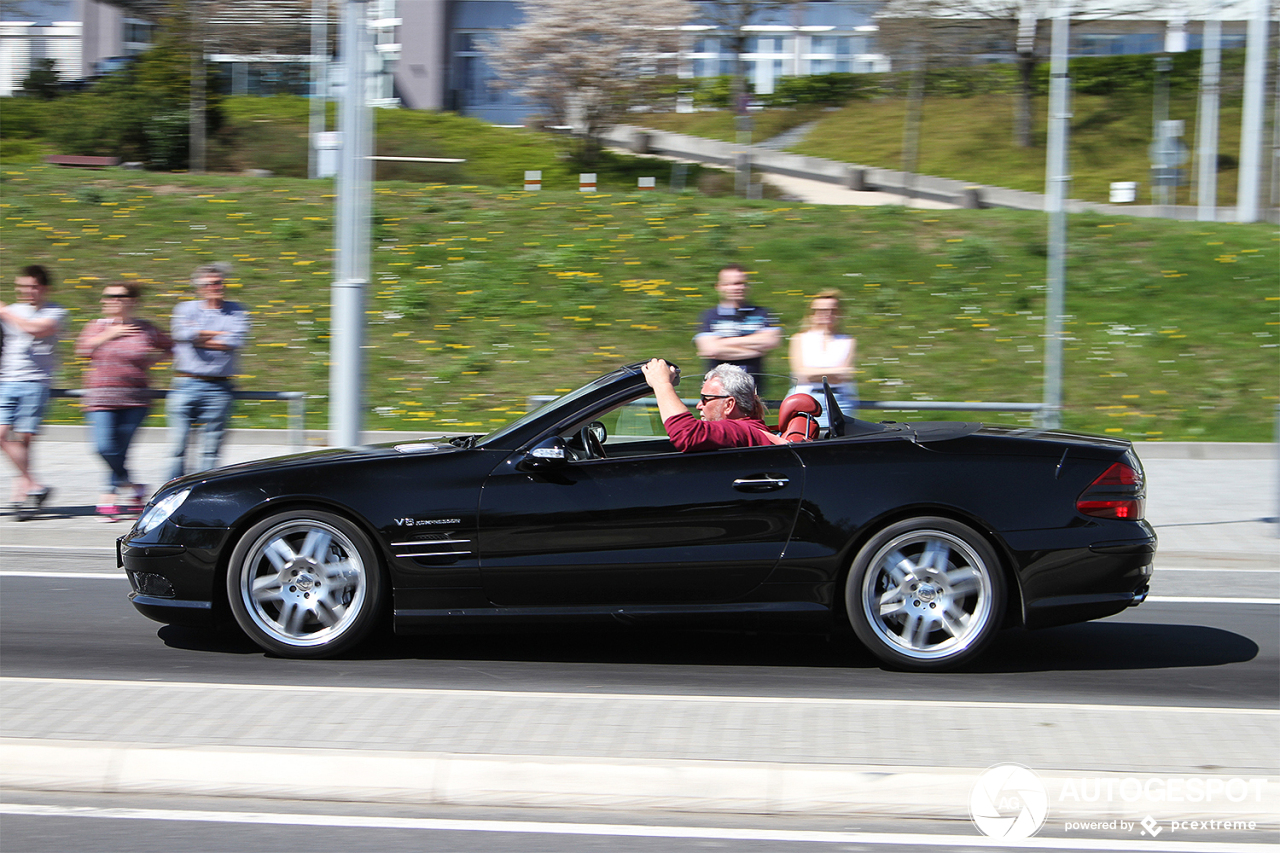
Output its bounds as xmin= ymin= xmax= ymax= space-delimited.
xmin=237 ymin=517 xmax=369 ymax=648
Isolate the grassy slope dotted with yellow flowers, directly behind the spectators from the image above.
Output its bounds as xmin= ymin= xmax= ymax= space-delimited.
xmin=0 ymin=159 xmax=1280 ymax=441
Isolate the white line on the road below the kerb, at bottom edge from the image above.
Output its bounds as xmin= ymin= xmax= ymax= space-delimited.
xmin=0 ymin=803 xmax=1275 ymax=853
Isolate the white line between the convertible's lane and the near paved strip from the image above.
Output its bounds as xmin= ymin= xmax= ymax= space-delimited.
xmin=0 ymin=675 xmax=1280 ymax=717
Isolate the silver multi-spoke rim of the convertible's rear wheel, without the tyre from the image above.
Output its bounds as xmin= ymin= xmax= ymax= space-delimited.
xmin=850 ymin=529 xmax=998 ymax=662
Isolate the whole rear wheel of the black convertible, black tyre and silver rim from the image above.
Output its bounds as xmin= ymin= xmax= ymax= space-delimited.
xmin=845 ymin=516 xmax=1005 ymax=671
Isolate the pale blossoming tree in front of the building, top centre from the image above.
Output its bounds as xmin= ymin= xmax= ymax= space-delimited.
xmin=485 ymin=0 xmax=694 ymax=165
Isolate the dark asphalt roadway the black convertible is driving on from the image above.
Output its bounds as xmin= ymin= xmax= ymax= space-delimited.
xmin=0 ymin=555 xmax=1280 ymax=708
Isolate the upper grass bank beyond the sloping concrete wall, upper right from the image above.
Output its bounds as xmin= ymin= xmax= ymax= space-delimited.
xmin=645 ymin=92 xmax=1240 ymax=205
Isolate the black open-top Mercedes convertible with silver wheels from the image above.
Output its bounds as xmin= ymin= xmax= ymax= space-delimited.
xmin=118 ymin=364 xmax=1156 ymax=670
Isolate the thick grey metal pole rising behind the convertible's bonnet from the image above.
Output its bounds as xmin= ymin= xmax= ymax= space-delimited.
xmin=329 ymin=0 xmax=372 ymax=447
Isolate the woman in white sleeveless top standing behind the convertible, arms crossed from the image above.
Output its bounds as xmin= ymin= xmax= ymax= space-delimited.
xmin=787 ymin=291 xmax=858 ymax=427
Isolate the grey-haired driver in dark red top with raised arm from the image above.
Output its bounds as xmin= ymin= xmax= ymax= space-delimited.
xmin=640 ymin=359 xmax=783 ymax=453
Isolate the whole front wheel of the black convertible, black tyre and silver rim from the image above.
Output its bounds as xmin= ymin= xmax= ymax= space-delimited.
xmin=227 ymin=511 xmax=383 ymax=657
